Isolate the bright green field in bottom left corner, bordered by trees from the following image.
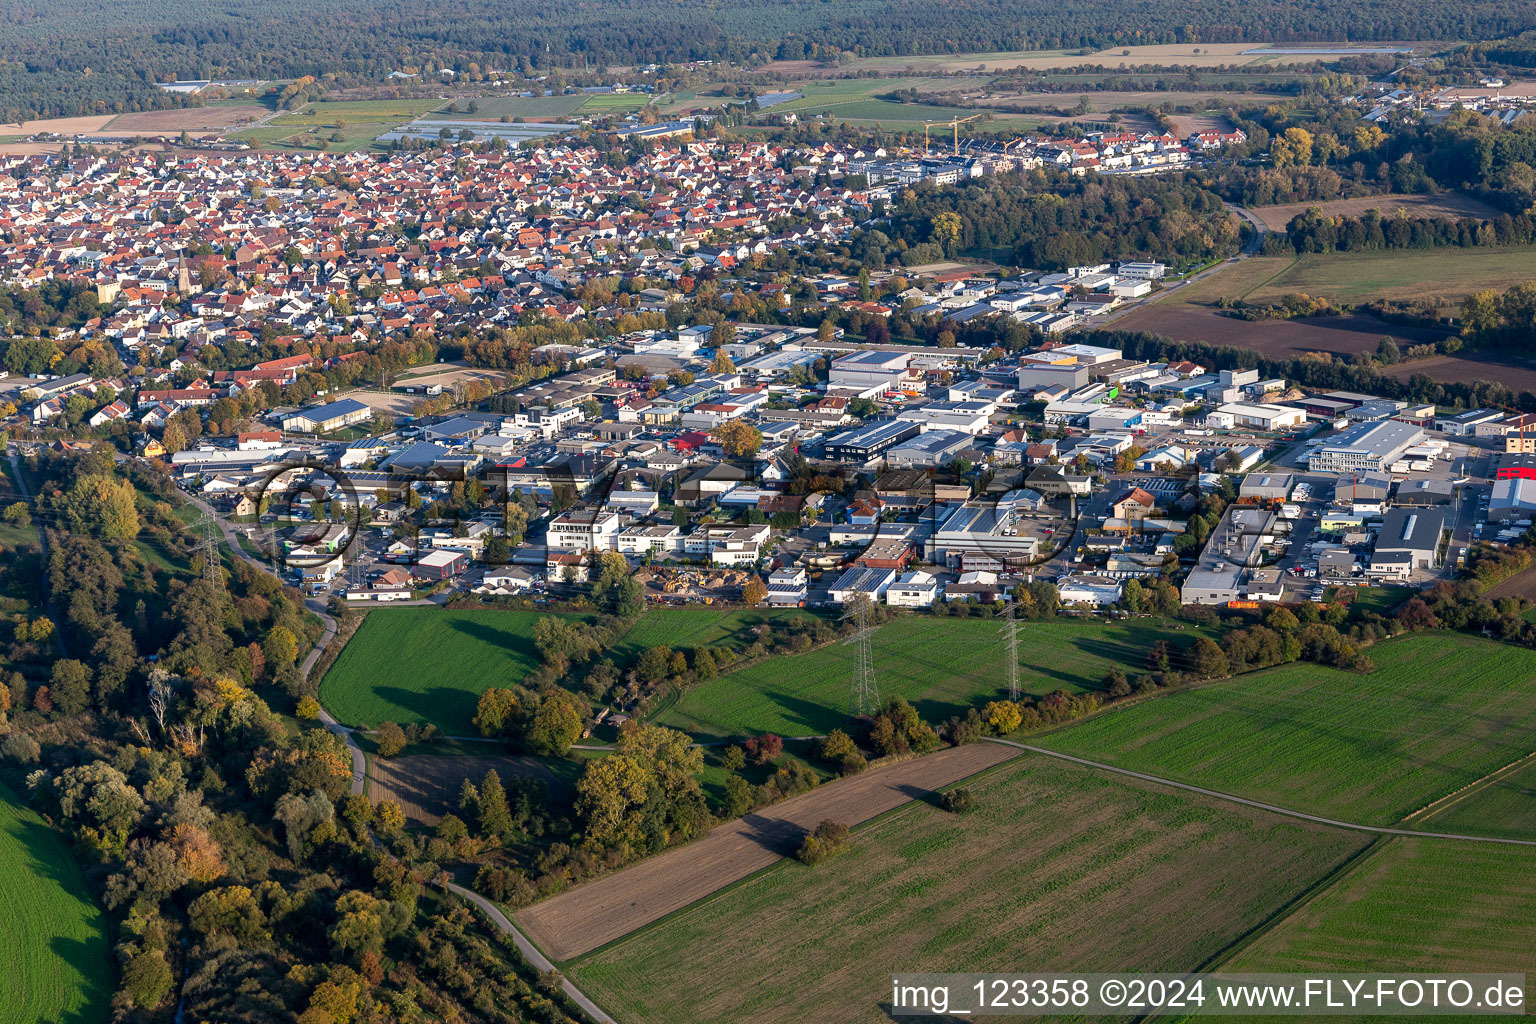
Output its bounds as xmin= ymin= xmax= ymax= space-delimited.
xmin=0 ymin=785 xmax=112 ymax=1024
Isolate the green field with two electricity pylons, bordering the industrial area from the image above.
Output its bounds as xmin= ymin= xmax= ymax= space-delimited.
xmin=657 ymin=616 xmax=1195 ymax=737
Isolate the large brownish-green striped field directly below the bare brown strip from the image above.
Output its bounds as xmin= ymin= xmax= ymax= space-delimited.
xmin=567 ymin=757 xmax=1366 ymax=1024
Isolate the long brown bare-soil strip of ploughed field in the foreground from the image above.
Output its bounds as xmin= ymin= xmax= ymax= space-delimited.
xmin=516 ymin=743 xmax=1018 ymax=961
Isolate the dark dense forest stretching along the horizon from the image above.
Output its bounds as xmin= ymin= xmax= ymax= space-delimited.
xmin=0 ymin=0 xmax=1536 ymax=121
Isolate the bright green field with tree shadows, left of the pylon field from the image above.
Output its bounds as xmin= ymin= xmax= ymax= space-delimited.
xmin=319 ymin=606 xmax=571 ymax=735
